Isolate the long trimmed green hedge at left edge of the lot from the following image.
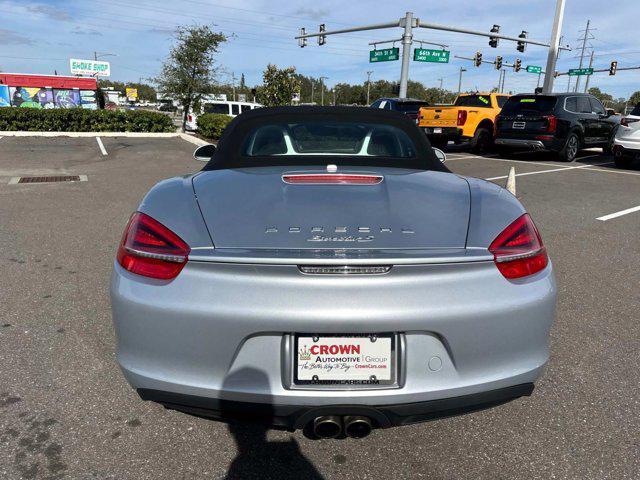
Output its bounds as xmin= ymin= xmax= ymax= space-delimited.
xmin=0 ymin=107 xmax=176 ymax=132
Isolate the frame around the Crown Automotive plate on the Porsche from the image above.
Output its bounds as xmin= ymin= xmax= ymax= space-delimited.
xmin=287 ymin=333 xmax=401 ymax=390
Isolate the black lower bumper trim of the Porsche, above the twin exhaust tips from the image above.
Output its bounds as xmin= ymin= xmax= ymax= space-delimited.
xmin=138 ymin=383 xmax=534 ymax=430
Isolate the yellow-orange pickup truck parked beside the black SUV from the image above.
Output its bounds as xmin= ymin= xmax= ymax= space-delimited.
xmin=418 ymin=93 xmax=509 ymax=153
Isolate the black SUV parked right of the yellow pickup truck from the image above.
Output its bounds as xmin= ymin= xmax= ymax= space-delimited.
xmin=495 ymin=93 xmax=620 ymax=162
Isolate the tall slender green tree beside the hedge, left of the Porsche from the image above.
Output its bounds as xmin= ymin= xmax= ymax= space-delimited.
xmin=156 ymin=25 xmax=227 ymax=131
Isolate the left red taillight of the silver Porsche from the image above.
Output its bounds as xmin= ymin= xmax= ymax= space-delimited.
xmin=117 ymin=212 xmax=191 ymax=280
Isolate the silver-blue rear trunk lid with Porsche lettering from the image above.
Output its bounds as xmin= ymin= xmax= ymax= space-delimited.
xmin=193 ymin=167 xmax=470 ymax=250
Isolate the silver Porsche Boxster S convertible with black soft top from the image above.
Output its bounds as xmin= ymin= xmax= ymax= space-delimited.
xmin=111 ymin=107 xmax=556 ymax=438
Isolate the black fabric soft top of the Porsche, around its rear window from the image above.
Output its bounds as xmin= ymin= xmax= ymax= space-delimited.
xmin=203 ymin=106 xmax=449 ymax=172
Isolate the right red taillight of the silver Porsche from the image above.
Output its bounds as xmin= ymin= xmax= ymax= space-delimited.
xmin=489 ymin=213 xmax=549 ymax=280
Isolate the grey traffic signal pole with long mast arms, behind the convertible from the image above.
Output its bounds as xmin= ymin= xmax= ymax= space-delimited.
xmin=295 ymin=11 xmax=568 ymax=98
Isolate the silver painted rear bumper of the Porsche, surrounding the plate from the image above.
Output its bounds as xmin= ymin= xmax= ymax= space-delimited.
xmin=111 ymin=261 xmax=556 ymax=428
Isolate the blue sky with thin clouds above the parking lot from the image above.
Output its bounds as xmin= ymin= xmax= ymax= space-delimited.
xmin=0 ymin=0 xmax=640 ymax=97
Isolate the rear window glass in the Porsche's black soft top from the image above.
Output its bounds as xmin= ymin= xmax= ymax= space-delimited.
xmin=241 ymin=120 xmax=416 ymax=158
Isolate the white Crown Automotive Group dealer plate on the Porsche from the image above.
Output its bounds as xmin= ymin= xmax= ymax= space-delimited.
xmin=294 ymin=335 xmax=395 ymax=385
